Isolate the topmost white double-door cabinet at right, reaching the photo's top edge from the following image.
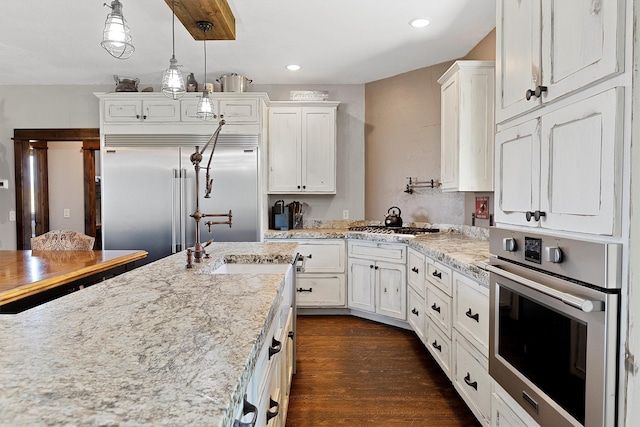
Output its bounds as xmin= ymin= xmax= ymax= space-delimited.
xmin=496 ymin=0 xmax=625 ymax=123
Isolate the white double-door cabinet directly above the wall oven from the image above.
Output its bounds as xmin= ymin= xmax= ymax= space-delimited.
xmin=495 ymin=88 xmax=623 ymax=235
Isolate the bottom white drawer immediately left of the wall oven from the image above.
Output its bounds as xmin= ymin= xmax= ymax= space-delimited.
xmin=453 ymin=334 xmax=491 ymax=425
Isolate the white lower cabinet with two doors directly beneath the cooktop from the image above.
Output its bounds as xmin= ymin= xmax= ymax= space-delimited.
xmin=348 ymin=241 xmax=407 ymax=320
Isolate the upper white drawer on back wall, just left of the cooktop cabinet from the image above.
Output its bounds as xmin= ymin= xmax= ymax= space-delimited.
xmin=298 ymin=240 xmax=345 ymax=273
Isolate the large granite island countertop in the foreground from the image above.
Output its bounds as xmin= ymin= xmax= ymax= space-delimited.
xmin=0 ymin=242 xmax=297 ymax=426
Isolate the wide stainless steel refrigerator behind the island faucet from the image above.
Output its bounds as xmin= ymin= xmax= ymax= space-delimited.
xmin=101 ymin=134 xmax=260 ymax=263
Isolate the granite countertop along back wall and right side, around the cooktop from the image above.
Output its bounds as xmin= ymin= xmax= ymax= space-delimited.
xmin=264 ymin=224 xmax=490 ymax=286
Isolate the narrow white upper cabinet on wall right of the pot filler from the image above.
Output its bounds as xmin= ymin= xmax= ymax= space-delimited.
xmin=438 ymin=61 xmax=495 ymax=191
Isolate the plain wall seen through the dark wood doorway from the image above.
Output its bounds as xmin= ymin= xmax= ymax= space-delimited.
xmin=47 ymin=141 xmax=84 ymax=233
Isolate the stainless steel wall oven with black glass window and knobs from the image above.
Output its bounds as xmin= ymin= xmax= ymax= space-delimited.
xmin=487 ymin=228 xmax=621 ymax=427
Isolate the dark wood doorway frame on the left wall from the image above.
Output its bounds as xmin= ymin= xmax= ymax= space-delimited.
xmin=13 ymin=128 xmax=102 ymax=250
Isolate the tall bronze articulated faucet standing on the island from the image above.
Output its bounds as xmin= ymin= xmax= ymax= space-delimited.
xmin=187 ymin=120 xmax=233 ymax=268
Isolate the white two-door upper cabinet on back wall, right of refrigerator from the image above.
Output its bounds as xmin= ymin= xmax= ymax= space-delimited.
xmin=269 ymin=101 xmax=338 ymax=194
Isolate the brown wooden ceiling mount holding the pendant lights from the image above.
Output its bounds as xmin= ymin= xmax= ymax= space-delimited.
xmin=164 ymin=0 xmax=236 ymax=40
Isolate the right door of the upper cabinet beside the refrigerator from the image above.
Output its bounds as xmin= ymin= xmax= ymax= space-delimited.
xmin=301 ymin=107 xmax=336 ymax=193
